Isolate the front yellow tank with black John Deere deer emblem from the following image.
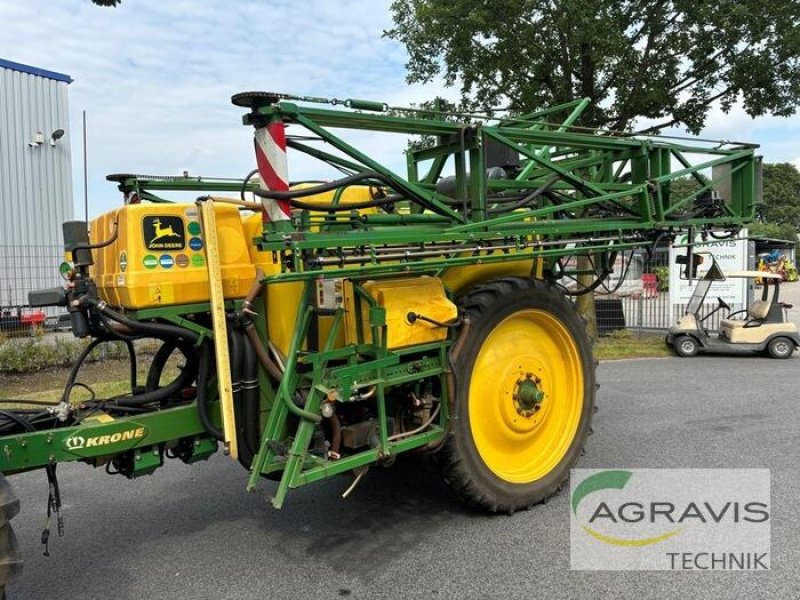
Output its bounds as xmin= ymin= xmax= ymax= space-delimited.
xmin=91 ymin=204 xmax=255 ymax=310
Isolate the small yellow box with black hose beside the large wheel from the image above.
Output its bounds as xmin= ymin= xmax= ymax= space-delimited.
xmin=345 ymin=277 xmax=458 ymax=350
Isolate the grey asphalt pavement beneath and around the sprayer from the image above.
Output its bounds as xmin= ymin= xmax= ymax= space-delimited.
xmin=3 ymin=356 xmax=800 ymax=600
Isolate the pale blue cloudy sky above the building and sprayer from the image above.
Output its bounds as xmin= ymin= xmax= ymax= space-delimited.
xmin=0 ymin=0 xmax=800 ymax=216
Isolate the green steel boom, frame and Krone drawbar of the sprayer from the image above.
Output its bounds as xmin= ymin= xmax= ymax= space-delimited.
xmin=0 ymin=94 xmax=760 ymax=507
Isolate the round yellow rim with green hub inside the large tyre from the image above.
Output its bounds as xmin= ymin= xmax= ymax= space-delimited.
xmin=469 ymin=309 xmax=584 ymax=483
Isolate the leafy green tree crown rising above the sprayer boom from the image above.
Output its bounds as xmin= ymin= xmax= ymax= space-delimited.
xmin=385 ymin=0 xmax=800 ymax=132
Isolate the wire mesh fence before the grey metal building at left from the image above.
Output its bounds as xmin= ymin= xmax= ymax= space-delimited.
xmin=0 ymin=245 xmax=69 ymax=336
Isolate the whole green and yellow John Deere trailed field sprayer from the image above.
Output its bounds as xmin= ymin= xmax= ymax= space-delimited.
xmin=0 ymin=92 xmax=760 ymax=583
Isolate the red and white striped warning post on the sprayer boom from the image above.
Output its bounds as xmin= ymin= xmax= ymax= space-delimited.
xmin=254 ymin=120 xmax=291 ymax=223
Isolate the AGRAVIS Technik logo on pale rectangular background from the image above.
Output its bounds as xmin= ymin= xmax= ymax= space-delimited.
xmin=570 ymin=469 xmax=770 ymax=570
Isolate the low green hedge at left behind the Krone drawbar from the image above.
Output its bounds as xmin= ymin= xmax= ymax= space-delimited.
xmin=0 ymin=336 xmax=128 ymax=374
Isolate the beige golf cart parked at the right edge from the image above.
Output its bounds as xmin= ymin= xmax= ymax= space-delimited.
xmin=666 ymin=255 xmax=800 ymax=358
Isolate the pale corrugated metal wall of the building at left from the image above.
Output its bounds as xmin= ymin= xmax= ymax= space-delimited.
xmin=0 ymin=67 xmax=74 ymax=306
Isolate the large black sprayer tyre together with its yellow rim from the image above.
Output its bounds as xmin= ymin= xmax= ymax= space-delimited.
xmin=436 ymin=278 xmax=596 ymax=513
